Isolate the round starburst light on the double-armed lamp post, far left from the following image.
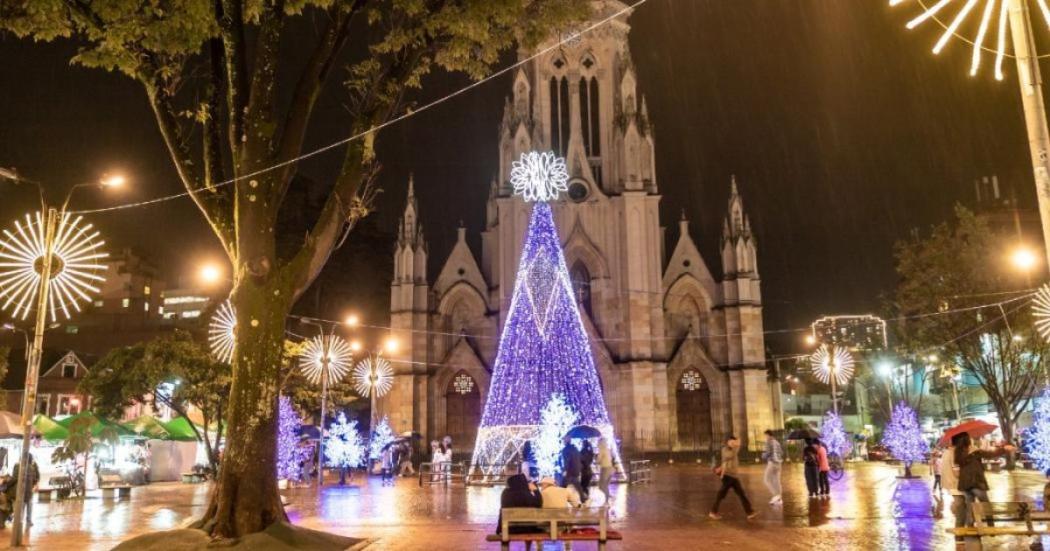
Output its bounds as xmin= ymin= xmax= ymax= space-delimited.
xmin=0 ymin=212 xmax=108 ymax=321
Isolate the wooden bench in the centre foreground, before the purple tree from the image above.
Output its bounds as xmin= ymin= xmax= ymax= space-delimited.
xmin=485 ymin=507 xmax=624 ymax=551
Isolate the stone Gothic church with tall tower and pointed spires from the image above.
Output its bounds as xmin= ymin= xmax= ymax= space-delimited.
xmin=386 ymin=0 xmax=782 ymax=452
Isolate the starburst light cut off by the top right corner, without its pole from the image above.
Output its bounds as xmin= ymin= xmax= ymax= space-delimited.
xmin=889 ymin=0 xmax=1050 ymax=80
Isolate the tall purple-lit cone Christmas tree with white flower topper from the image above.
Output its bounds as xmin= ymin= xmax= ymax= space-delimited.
xmin=473 ymin=152 xmax=615 ymax=476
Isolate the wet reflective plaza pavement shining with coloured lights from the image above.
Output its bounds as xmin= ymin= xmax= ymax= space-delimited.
xmin=0 ymin=463 xmax=1050 ymax=551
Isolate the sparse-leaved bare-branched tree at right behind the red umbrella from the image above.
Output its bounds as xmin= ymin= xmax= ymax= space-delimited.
xmin=895 ymin=207 xmax=1050 ymax=455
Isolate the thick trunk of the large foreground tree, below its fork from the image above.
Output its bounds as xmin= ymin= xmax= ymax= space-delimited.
xmin=203 ymin=277 xmax=290 ymax=537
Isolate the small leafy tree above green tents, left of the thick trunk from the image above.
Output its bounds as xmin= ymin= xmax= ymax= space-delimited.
xmin=80 ymin=333 xmax=230 ymax=472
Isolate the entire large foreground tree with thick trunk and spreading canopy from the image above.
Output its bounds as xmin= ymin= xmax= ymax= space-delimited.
xmin=0 ymin=0 xmax=589 ymax=537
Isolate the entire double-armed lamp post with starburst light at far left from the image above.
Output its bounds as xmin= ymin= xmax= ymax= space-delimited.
xmin=0 ymin=169 xmax=119 ymax=547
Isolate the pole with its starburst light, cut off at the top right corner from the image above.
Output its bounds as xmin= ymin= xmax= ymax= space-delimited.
xmin=889 ymin=0 xmax=1050 ymax=263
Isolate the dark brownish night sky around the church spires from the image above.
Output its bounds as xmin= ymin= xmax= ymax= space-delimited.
xmin=0 ymin=0 xmax=1034 ymax=350
